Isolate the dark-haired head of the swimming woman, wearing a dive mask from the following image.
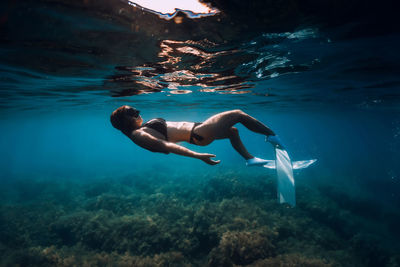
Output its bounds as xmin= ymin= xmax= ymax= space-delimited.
xmin=110 ymin=106 xmax=143 ymax=135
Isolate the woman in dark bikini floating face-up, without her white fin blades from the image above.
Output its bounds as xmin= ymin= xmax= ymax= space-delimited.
xmin=110 ymin=106 xmax=283 ymax=166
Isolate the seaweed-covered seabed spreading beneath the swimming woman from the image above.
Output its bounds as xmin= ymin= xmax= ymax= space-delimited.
xmin=0 ymin=172 xmax=400 ymax=267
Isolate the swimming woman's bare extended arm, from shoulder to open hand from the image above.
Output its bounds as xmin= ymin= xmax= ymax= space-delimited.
xmin=129 ymin=130 xmax=220 ymax=165
